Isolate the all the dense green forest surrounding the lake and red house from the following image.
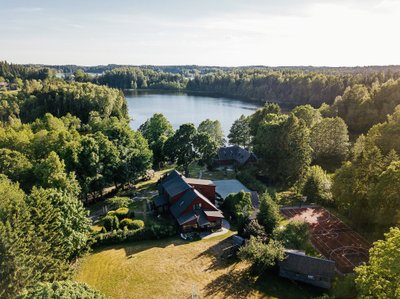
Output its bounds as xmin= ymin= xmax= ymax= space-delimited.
xmin=0 ymin=62 xmax=400 ymax=298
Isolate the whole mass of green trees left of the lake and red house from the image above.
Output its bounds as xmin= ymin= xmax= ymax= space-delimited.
xmin=0 ymin=67 xmax=152 ymax=298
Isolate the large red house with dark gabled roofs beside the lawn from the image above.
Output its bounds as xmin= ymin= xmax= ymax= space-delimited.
xmin=154 ymin=170 xmax=224 ymax=232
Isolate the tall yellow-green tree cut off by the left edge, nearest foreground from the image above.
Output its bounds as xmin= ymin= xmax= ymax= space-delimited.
xmin=0 ymin=175 xmax=70 ymax=298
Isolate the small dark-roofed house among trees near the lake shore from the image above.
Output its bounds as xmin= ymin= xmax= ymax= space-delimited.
xmin=214 ymin=145 xmax=257 ymax=167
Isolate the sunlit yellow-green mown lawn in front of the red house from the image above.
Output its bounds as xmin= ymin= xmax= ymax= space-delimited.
xmin=75 ymin=232 xmax=320 ymax=299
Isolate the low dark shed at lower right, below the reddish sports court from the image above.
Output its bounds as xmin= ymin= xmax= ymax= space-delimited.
xmin=279 ymin=249 xmax=335 ymax=289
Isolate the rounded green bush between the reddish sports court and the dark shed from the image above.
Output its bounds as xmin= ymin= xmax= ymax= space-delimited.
xmin=274 ymin=220 xmax=310 ymax=250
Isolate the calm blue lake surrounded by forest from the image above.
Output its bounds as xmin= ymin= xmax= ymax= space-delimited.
xmin=125 ymin=91 xmax=259 ymax=136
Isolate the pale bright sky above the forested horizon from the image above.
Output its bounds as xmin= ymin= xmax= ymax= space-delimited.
xmin=0 ymin=0 xmax=400 ymax=66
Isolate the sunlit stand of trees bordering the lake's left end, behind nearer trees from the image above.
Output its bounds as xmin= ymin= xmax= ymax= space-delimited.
xmin=0 ymin=79 xmax=128 ymax=123
